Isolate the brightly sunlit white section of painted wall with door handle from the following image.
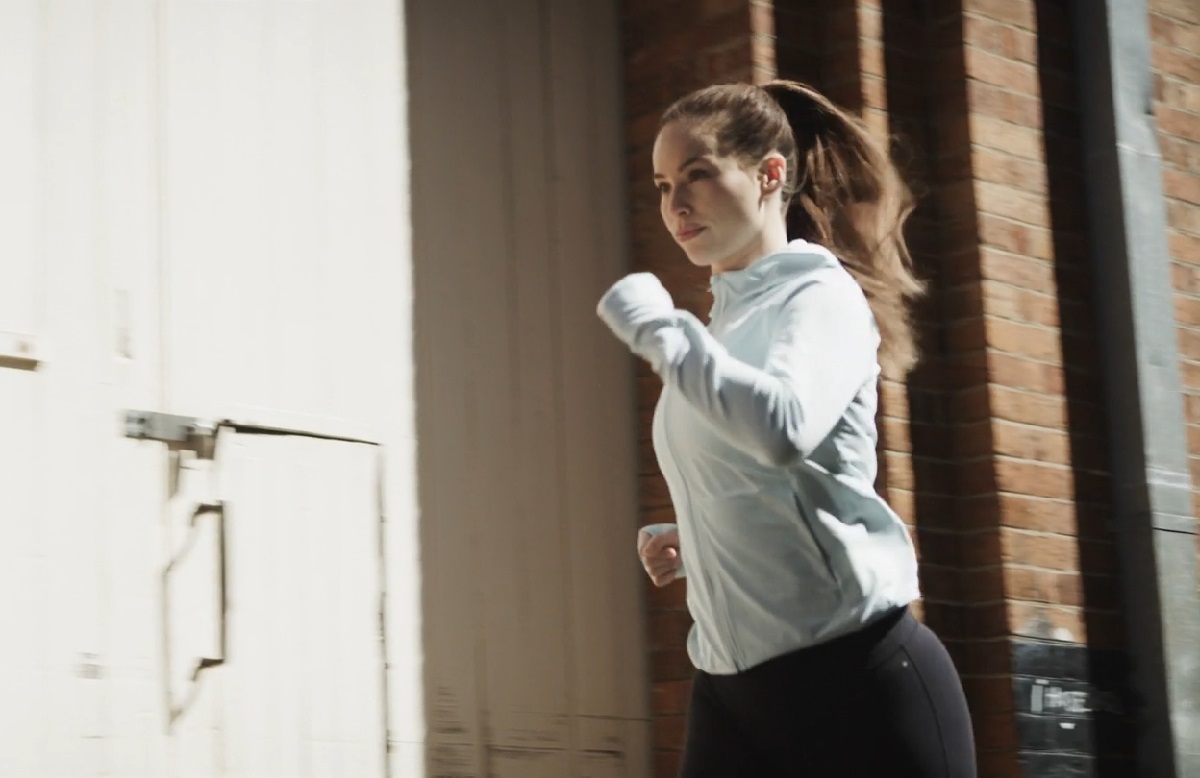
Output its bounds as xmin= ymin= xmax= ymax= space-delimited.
xmin=0 ymin=0 xmax=425 ymax=777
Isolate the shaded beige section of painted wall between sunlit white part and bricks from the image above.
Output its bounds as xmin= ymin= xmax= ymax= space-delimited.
xmin=407 ymin=0 xmax=649 ymax=778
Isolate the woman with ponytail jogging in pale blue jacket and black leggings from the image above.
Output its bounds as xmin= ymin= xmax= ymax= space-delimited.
xmin=599 ymin=82 xmax=976 ymax=778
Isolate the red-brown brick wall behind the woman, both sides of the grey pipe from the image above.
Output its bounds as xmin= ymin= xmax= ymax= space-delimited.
xmin=625 ymin=0 xmax=1185 ymax=778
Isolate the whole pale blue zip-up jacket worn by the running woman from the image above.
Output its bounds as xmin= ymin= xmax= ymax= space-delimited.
xmin=599 ymin=240 xmax=919 ymax=675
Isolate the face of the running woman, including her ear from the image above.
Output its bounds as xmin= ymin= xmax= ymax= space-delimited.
xmin=654 ymin=121 xmax=786 ymax=273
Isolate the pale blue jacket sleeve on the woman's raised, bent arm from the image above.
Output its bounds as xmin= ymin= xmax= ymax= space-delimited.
xmin=600 ymin=269 xmax=880 ymax=466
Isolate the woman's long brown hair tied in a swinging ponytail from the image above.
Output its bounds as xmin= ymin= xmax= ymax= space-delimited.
xmin=660 ymin=80 xmax=924 ymax=378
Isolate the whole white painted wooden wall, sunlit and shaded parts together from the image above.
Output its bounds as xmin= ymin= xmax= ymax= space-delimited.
xmin=0 ymin=0 xmax=649 ymax=778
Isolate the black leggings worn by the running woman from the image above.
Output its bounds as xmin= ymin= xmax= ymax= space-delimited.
xmin=680 ymin=608 xmax=976 ymax=778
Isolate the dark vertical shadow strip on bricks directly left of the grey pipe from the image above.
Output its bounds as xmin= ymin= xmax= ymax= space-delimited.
xmin=1032 ymin=0 xmax=1134 ymax=776
